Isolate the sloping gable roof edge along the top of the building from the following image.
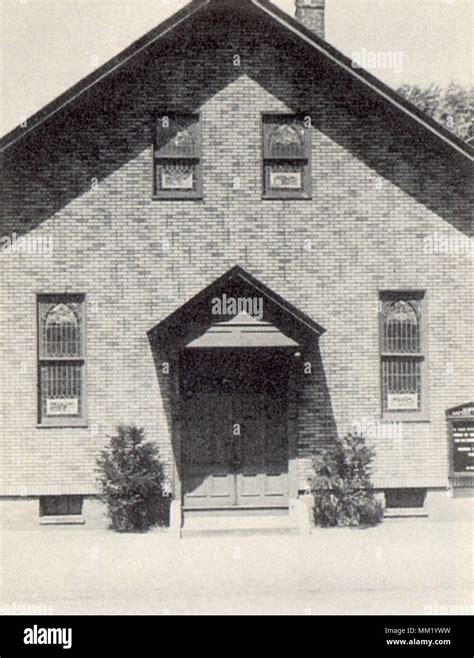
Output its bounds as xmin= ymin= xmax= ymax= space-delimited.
xmin=0 ymin=0 xmax=474 ymax=160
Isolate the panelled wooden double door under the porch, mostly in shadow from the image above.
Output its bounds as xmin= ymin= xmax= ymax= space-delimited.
xmin=180 ymin=348 xmax=288 ymax=509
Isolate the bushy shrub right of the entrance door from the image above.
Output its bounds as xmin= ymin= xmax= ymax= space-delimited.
xmin=310 ymin=434 xmax=383 ymax=527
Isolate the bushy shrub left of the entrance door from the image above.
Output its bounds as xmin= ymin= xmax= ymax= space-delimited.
xmin=97 ymin=426 xmax=168 ymax=532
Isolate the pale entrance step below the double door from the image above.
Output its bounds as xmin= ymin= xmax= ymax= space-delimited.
xmin=181 ymin=510 xmax=299 ymax=537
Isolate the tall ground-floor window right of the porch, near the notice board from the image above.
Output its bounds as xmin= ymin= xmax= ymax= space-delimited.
xmin=380 ymin=293 xmax=426 ymax=416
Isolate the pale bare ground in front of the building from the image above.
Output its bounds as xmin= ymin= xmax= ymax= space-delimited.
xmin=0 ymin=519 xmax=474 ymax=615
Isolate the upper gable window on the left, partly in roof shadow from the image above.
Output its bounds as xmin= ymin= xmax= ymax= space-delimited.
xmin=154 ymin=114 xmax=202 ymax=199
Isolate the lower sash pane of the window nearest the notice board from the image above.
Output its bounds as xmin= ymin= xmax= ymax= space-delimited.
xmin=382 ymin=357 xmax=421 ymax=411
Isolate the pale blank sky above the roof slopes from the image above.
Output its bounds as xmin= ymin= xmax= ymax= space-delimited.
xmin=0 ymin=0 xmax=474 ymax=135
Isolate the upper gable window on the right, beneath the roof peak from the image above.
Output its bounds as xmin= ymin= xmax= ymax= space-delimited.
xmin=263 ymin=115 xmax=311 ymax=199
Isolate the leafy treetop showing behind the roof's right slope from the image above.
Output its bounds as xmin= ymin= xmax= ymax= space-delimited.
xmin=397 ymin=82 xmax=474 ymax=141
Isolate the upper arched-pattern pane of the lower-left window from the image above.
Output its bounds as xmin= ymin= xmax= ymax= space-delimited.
xmin=40 ymin=303 xmax=81 ymax=358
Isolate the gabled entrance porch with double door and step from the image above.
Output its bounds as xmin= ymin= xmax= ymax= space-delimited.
xmin=150 ymin=268 xmax=324 ymax=533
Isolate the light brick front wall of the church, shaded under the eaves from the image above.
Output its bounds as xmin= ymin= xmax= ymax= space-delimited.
xmin=0 ymin=3 xmax=474 ymax=496
